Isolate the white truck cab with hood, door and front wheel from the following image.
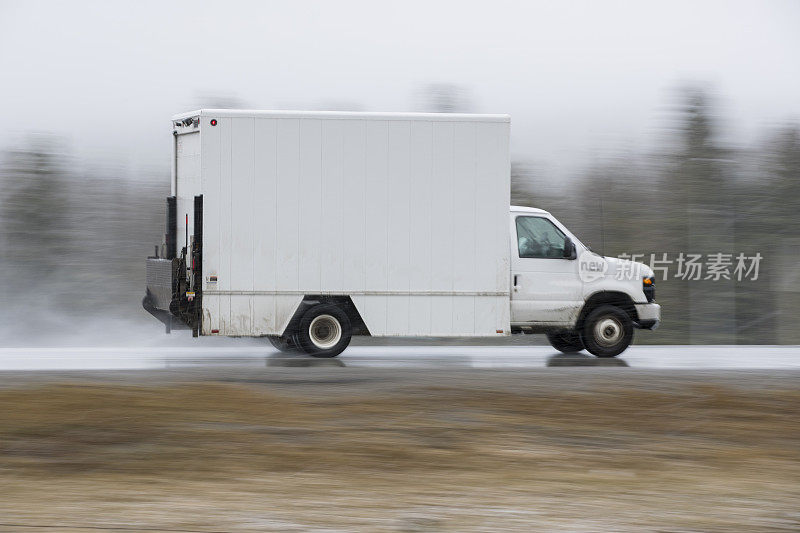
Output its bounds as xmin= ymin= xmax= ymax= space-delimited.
xmin=509 ymin=206 xmax=661 ymax=357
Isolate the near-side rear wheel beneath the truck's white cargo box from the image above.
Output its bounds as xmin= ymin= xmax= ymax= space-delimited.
xmin=294 ymin=304 xmax=353 ymax=357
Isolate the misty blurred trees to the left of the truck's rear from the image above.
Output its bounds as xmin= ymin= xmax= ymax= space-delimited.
xmin=0 ymin=135 xmax=169 ymax=337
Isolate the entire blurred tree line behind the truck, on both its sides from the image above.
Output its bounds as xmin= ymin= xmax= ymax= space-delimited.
xmin=0 ymin=85 xmax=800 ymax=344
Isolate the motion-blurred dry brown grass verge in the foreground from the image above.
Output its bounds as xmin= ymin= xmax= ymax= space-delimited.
xmin=0 ymin=376 xmax=800 ymax=531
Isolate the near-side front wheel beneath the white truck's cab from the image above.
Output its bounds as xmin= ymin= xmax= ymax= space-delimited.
xmin=582 ymin=305 xmax=633 ymax=357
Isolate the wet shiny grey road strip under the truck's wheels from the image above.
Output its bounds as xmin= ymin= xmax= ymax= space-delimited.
xmin=0 ymin=339 xmax=800 ymax=371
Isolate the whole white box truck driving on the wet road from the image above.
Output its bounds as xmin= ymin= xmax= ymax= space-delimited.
xmin=143 ymin=109 xmax=660 ymax=357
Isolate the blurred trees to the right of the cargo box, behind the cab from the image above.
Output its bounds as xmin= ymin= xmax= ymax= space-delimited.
xmin=511 ymin=87 xmax=800 ymax=344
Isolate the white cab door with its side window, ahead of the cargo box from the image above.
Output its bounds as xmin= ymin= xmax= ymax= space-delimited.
xmin=511 ymin=213 xmax=583 ymax=326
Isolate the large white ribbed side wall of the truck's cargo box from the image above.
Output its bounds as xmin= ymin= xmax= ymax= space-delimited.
xmin=192 ymin=114 xmax=509 ymax=336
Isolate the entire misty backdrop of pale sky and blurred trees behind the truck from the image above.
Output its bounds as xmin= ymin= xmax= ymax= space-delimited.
xmin=0 ymin=1 xmax=800 ymax=345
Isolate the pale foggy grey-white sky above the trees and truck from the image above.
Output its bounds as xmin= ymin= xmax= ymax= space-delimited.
xmin=0 ymin=0 xmax=800 ymax=180
